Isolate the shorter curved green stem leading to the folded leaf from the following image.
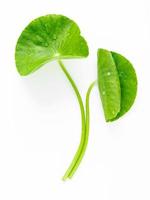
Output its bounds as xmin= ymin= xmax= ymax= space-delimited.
xmin=68 ymin=81 xmax=96 ymax=178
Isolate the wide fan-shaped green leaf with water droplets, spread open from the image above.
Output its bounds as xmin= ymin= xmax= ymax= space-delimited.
xmin=15 ymin=15 xmax=89 ymax=75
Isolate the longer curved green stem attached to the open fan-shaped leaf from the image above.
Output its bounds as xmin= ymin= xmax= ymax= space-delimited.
xmin=58 ymin=60 xmax=85 ymax=180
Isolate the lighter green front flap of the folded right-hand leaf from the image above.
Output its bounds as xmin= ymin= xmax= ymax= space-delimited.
xmin=98 ymin=49 xmax=121 ymax=121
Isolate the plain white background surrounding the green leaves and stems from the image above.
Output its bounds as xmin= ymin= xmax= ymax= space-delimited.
xmin=0 ymin=0 xmax=150 ymax=200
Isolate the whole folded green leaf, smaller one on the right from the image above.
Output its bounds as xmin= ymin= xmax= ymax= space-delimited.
xmin=98 ymin=49 xmax=137 ymax=121
